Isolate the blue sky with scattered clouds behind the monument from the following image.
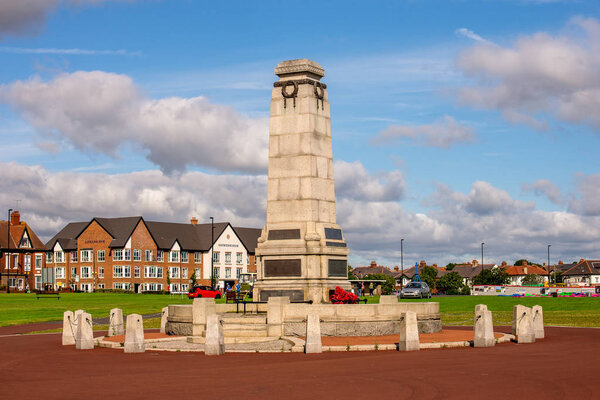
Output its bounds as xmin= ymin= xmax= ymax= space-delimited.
xmin=0 ymin=0 xmax=600 ymax=267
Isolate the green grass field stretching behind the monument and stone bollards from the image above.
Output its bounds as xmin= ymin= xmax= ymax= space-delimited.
xmin=0 ymin=293 xmax=600 ymax=327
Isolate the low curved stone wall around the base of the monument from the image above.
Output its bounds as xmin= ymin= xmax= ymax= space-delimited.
xmin=165 ymin=302 xmax=442 ymax=336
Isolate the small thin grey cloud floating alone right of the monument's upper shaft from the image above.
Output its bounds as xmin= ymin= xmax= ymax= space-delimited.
xmin=373 ymin=115 xmax=477 ymax=148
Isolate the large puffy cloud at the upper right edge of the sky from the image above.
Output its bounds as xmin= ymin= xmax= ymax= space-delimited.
xmin=458 ymin=18 xmax=600 ymax=131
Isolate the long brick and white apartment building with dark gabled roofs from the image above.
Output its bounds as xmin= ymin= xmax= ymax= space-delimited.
xmin=46 ymin=216 xmax=260 ymax=293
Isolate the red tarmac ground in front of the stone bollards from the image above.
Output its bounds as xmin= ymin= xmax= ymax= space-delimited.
xmin=0 ymin=327 xmax=600 ymax=400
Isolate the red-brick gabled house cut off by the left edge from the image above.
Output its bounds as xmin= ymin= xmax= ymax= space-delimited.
xmin=0 ymin=211 xmax=46 ymax=292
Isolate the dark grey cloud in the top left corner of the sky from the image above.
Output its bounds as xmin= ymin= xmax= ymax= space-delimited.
xmin=0 ymin=0 xmax=135 ymax=38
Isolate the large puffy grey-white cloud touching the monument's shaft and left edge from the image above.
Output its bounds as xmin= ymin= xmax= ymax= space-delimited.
xmin=0 ymin=71 xmax=268 ymax=173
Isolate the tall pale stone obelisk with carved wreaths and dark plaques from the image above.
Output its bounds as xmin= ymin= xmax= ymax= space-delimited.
xmin=254 ymin=59 xmax=350 ymax=303
